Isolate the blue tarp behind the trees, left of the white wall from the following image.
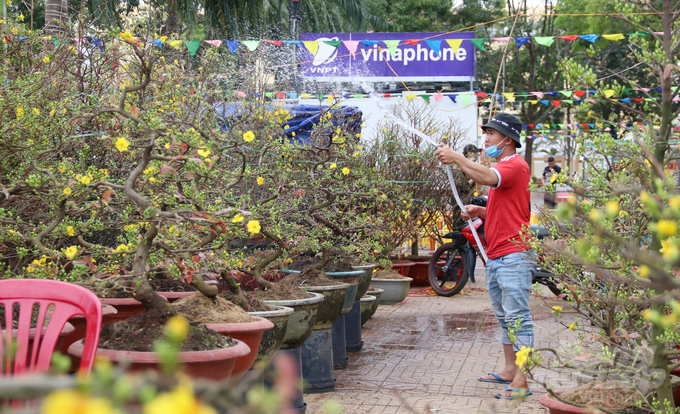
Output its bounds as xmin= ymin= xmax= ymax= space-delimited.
xmin=215 ymin=102 xmax=363 ymax=144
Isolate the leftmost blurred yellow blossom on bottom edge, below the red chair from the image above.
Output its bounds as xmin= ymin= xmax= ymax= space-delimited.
xmin=41 ymin=389 xmax=119 ymax=414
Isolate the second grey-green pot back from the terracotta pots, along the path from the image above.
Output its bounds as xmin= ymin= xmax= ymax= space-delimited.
xmin=264 ymin=292 xmax=324 ymax=349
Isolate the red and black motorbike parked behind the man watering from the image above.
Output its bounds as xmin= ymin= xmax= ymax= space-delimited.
xmin=427 ymin=196 xmax=562 ymax=296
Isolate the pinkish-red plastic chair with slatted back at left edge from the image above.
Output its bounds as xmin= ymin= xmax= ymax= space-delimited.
xmin=0 ymin=279 xmax=102 ymax=377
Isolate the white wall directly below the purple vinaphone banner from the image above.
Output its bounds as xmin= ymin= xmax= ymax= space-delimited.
xmin=296 ymin=92 xmax=480 ymax=147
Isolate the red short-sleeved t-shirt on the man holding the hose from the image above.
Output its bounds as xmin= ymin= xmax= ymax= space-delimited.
xmin=484 ymin=154 xmax=531 ymax=259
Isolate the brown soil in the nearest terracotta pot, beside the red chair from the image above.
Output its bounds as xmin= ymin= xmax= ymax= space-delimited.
xmin=99 ymin=309 xmax=231 ymax=352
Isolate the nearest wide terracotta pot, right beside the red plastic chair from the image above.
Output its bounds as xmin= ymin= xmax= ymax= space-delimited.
xmin=68 ymin=340 xmax=250 ymax=381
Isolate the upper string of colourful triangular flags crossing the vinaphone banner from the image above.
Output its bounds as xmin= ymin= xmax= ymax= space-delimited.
xmin=30 ymin=31 xmax=663 ymax=56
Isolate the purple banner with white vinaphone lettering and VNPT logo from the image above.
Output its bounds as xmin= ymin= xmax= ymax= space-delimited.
xmin=300 ymin=32 xmax=475 ymax=82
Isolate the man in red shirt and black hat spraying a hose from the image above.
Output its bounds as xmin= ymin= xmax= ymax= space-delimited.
xmin=435 ymin=113 xmax=535 ymax=399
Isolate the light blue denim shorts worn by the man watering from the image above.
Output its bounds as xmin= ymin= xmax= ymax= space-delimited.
xmin=486 ymin=250 xmax=536 ymax=351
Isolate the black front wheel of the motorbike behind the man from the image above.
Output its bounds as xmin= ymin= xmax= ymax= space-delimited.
xmin=427 ymin=243 xmax=468 ymax=297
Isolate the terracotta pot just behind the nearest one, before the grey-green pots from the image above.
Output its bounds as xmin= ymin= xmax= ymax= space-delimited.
xmin=205 ymin=316 xmax=274 ymax=383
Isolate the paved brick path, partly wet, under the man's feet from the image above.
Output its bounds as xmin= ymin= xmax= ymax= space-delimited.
xmin=304 ymin=265 xmax=576 ymax=414
